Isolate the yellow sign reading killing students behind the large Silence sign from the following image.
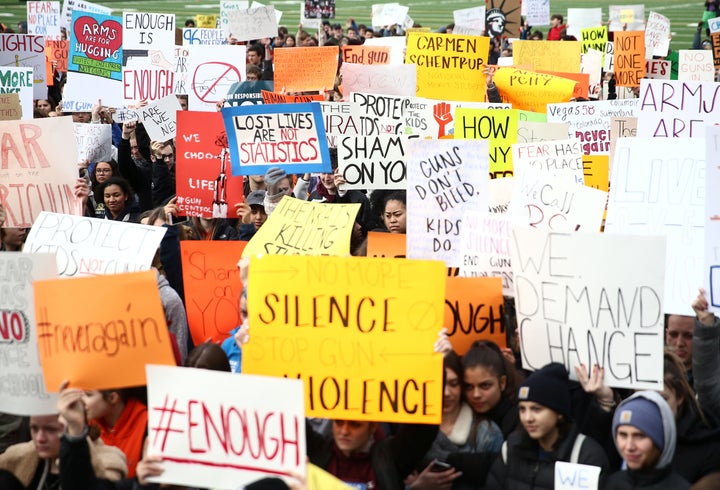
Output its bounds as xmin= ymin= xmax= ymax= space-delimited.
xmin=242 ymin=196 xmax=360 ymax=257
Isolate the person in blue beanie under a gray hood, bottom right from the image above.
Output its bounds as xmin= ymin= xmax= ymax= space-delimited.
xmin=607 ymin=391 xmax=690 ymax=490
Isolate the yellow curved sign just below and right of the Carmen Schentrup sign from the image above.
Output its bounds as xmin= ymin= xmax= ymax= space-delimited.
xmin=495 ymin=67 xmax=577 ymax=114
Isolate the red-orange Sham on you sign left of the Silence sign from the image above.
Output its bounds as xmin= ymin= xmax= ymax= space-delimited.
xmin=180 ymin=240 xmax=247 ymax=345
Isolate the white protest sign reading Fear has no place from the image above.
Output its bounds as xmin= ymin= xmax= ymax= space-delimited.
xmin=512 ymin=138 xmax=583 ymax=184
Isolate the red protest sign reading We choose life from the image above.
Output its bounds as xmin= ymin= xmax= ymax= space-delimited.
xmin=175 ymin=111 xmax=245 ymax=218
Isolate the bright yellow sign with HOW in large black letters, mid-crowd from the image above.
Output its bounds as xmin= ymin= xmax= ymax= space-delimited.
xmin=455 ymin=108 xmax=519 ymax=178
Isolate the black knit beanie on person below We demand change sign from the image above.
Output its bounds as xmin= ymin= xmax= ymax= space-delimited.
xmin=518 ymin=362 xmax=572 ymax=418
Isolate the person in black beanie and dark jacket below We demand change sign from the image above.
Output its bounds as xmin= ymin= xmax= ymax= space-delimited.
xmin=485 ymin=363 xmax=609 ymax=490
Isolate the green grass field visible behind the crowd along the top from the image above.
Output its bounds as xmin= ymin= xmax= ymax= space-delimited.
xmin=0 ymin=0 xmax=703 ymax=49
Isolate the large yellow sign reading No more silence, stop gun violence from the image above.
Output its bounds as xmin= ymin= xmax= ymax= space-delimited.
xmin=242 ymin=255 xmax=445 ymax=424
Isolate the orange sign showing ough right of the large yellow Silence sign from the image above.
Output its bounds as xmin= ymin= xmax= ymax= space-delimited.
xmin=444 ymin=277 xmax=507 ymax=355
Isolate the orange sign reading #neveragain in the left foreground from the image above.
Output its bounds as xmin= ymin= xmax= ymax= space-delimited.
xmin=33 ymin=270 xmax=175 ymax=392
